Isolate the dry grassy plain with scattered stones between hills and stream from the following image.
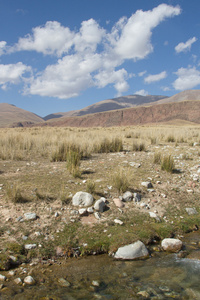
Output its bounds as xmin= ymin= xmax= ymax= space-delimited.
xmin=0 ymin=125 xmax=200 ymax=269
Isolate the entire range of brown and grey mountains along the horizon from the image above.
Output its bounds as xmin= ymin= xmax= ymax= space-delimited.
xmin=0 ymin=90 xmax=200 ymax=127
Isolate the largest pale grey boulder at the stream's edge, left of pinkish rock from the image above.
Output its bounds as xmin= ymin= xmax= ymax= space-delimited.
xmin=114 ymin=241 xmax=149 ymax=260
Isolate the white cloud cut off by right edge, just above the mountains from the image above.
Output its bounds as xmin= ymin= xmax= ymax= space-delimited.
xmin=173 ymin=67 xmax=200 ymax=91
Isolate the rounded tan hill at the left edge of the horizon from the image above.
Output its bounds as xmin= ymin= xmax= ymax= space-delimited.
xmin=0 ymin=103 xmax=44 ymax=127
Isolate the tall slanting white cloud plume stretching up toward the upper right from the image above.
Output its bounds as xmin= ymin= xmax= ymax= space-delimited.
xmin=111 ymin=4 xmax=181 ymax=60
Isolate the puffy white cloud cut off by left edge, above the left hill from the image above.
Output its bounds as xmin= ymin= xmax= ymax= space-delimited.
xmin=0 ymin=62 xmax=31 ymax=90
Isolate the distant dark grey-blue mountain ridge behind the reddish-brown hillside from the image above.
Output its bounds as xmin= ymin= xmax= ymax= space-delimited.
xmin=44 ymin=95 xmax=168 ymax=121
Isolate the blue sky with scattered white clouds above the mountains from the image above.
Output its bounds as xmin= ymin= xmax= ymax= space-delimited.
xmin=0 ymin=0 xmax=200 ymax=117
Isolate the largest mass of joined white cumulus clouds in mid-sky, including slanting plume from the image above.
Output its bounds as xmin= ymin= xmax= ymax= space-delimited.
xmin=4 ymin=4 xmax=181 ymax=99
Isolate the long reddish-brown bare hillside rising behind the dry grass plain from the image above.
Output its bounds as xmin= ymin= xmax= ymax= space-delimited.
xmin=37 ymin=101 xmax=200 ymax=127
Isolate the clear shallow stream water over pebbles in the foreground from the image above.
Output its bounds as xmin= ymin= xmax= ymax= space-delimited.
xmin=0 ymin=233 xmax=200 ymax=300
